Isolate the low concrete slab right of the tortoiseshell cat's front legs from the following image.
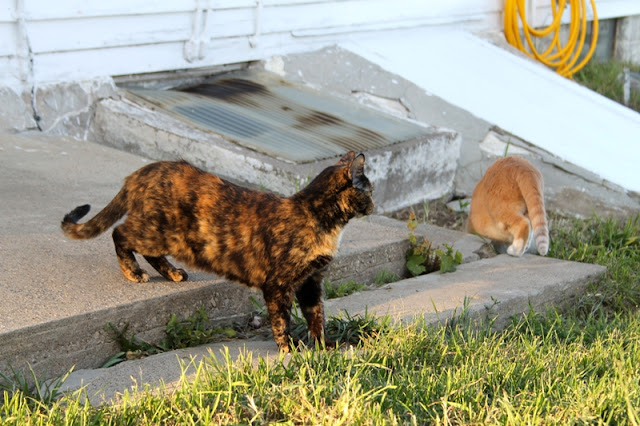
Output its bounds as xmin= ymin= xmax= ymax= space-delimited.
xmin=326 ymin=255 xmax=606 ymax=328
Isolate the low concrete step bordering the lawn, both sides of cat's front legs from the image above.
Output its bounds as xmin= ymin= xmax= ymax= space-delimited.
xmin=58 ymin=253 xmax=606 ymax=404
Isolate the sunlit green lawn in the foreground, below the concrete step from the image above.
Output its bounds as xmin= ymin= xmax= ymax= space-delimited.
xmin=0 ymin=216 xmax=640 ymax=425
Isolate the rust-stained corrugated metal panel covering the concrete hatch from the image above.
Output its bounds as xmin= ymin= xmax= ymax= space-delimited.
xmin=131 ymin=70 xmax=428 ymax=163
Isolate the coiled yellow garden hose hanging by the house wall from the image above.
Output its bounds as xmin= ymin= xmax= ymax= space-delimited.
xmin=504 ymin=0 xmax=598 ymax=78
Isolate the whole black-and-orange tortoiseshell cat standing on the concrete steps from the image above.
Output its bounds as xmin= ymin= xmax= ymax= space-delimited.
xmin=62 ymin=152 xmax=373 ymax=351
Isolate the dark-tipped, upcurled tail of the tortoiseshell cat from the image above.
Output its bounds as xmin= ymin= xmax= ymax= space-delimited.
xmin=61 ymin=188 xmax=127 ymax=240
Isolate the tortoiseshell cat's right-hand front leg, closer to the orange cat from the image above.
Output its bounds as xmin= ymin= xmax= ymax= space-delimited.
xmin=296 ymin=272 xmax=335 ymax=346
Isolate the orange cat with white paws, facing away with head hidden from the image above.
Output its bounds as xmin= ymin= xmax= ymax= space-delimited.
xmin=467 ymin=157 xmax=549 ymax=257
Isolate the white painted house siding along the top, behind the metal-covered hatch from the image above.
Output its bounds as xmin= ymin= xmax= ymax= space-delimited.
xmin=5 ymin=0 xmax=640 ymax=92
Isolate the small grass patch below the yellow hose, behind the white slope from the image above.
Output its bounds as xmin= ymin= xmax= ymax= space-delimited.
xmin=573 ymin=61 xmax=640 ymax=112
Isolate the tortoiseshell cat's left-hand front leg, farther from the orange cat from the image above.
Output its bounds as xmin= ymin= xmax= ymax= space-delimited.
xmin=262 ymin=284 xmax=293 ymax=352
